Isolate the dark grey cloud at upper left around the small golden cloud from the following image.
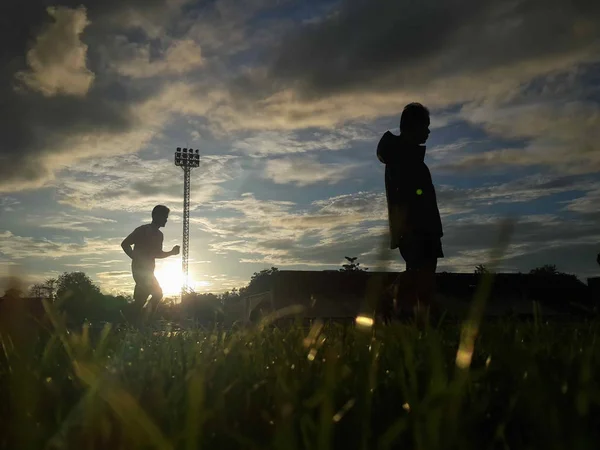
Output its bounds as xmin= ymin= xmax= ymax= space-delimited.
xmin=0 ymin=0 xmax=173 ymax=191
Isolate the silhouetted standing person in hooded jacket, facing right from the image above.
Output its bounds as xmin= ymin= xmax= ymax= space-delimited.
xmin=377 ymin=103 xmax=444 ymax=319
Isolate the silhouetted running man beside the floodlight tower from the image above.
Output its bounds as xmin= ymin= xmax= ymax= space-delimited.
xmin=121 ymin=205 xmax=179 ymax=319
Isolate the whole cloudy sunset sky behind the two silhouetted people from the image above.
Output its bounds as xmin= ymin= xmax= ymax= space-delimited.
xmin=0 ymin=0 xmax=600 ymax=294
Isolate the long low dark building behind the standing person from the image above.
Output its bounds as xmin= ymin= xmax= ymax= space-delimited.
xmin=244 ymin=270 xmax=598 ymax=322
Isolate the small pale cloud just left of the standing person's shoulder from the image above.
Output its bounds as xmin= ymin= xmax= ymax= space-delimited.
xmin=263 ymin=158 xmax=359 ymax=187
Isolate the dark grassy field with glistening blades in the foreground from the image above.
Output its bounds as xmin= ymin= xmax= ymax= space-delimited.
xmin=0 ymin=298 xmax=600 ymax=450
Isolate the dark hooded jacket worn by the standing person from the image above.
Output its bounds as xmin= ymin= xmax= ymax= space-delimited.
xmin=377 ymin=131 xmax=444 ymax=249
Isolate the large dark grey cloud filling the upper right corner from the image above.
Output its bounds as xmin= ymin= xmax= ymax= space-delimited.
xmin=270 ymin=0 xmax=600 ymax=97
